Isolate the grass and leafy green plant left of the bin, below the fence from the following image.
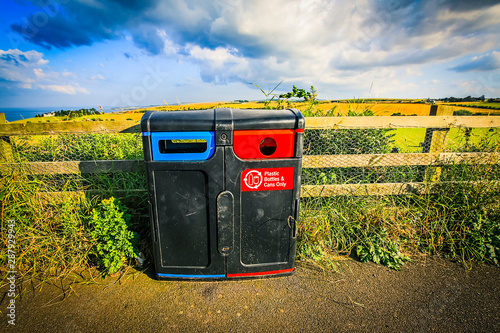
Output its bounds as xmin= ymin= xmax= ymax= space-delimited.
xmin=0 ymin=164 xmax=149 ymax=286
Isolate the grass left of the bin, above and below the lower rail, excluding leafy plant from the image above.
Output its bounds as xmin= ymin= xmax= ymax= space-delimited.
xmin=0 ymin=134 xmax=149 ymax=286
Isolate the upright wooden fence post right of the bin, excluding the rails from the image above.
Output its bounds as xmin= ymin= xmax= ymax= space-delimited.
xmin=422 ymin=104 xmax=454 ymax=183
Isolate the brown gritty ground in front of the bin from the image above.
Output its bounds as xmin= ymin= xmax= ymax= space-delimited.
xmin=0 ymin=258 xmax=500 ymax=332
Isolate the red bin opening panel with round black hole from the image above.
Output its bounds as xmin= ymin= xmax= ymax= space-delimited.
xmin=233 ymin=129 xmax=295 ymax=159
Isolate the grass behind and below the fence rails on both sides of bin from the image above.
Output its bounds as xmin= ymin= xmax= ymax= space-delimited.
xmin=0 ymin=107 xmax=500 ymax=279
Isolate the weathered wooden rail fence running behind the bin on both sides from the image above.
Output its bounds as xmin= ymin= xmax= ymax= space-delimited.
xmin=0 ymin=106 xmax=500 ymax=197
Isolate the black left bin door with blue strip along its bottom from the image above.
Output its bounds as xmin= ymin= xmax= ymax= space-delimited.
xmin=147 ymin=149 xmax=225 ymax=278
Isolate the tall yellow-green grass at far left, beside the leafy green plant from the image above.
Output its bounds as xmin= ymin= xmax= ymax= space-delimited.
xmin=0 ymin=167 xmax=94 ymax=280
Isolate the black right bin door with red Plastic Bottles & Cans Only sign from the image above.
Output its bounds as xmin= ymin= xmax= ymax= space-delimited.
xmin=226 ymin=149 xmax=300 ymax=277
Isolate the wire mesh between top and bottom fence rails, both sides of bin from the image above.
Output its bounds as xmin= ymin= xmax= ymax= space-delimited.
xmin=1 ymin=122 xmax=500 ymax=195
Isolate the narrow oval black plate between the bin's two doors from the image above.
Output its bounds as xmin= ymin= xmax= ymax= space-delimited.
xmin=217 ymin=191 xmax=234 ymax=256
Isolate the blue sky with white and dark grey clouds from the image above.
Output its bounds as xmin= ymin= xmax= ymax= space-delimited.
xmin=0 ymin=0 xmax=500 ymax=107
